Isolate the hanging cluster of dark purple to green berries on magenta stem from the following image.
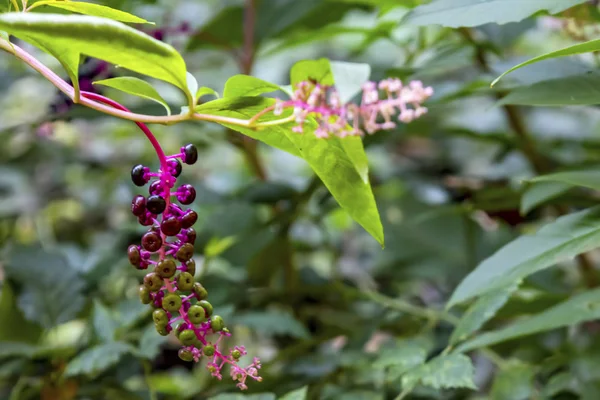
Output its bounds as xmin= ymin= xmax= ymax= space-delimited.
xmin=127 ymin=144 xmax=262 ymax=389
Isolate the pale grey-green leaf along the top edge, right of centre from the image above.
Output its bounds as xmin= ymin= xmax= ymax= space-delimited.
xmin=403 ymin=0 xmax=586 ymax=28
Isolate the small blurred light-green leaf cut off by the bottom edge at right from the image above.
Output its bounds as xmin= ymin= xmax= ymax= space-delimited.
xmin=491 ymin=361 xmax=536 ymax=400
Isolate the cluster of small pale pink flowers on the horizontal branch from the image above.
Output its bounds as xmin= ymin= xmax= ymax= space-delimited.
xmin=273 ymin=78 xmax=433 ymax=138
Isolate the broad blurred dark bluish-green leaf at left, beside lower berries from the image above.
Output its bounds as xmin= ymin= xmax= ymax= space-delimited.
xmin=5 ymin=246 xmax=85 ymax=328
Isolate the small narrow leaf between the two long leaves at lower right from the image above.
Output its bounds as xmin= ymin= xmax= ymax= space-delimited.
xmin=450 ymin=284 xmax=518 ymax=345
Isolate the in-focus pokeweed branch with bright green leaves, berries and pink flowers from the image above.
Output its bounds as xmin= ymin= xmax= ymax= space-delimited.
xmin=0 ymin=0 xmax=433 ymax=390
